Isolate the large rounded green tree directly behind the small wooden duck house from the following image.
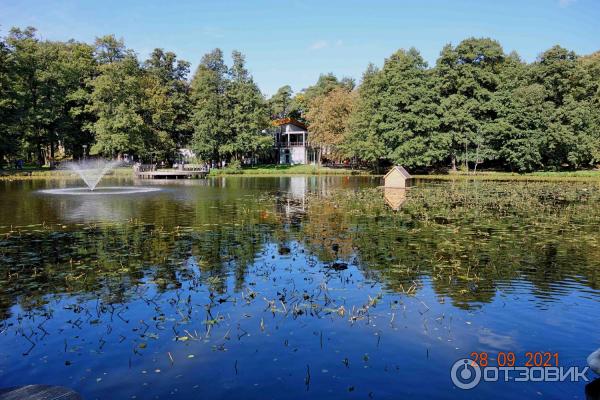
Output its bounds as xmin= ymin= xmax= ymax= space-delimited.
xmin=345 ymin=49 xmax=442 ymax=167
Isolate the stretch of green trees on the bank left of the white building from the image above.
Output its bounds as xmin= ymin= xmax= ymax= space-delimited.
xmin=0 ymin=28 xmax=272 ymax=167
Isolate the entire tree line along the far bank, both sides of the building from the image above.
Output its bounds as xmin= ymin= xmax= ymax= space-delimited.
xmin=0 ymin=28 xmax=600 ymax=171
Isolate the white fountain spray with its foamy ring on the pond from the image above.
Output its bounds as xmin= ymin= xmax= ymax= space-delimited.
xmin=40 ymin=158 xmax=160 ymax=195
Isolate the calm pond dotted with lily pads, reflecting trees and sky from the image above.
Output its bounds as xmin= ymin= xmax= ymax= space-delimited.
xmin=0 ymin=176 xmax=600 ymax=399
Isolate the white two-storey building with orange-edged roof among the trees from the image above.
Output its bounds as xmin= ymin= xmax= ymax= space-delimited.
xmin=272 ymin=118 xmax=317 ymax=164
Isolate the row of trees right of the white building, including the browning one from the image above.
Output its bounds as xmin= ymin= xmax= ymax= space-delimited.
xmin=305 ymin=38 xmax=600 ymax=172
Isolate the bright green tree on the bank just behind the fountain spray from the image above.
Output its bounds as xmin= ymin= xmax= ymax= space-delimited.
xmin=87 ymin=36 xmax=176 ymax=161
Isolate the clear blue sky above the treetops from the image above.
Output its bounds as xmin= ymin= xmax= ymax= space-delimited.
xmin=0 ymin=0 xmax=600 ymax=94
